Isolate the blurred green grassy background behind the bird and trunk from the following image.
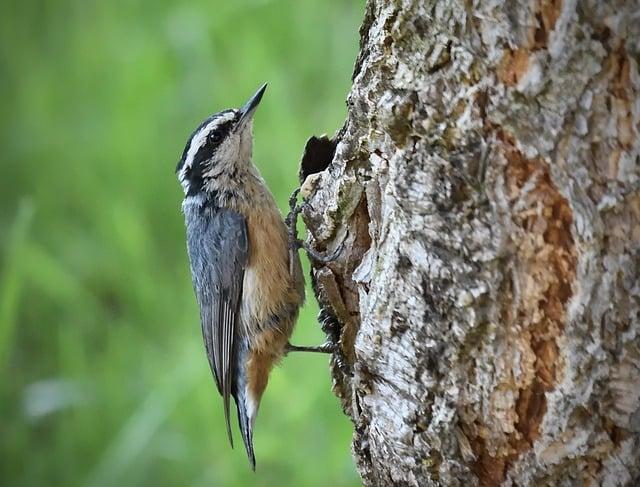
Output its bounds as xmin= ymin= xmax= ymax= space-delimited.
xmin=0 ymin=0 xmax=364 ymax=486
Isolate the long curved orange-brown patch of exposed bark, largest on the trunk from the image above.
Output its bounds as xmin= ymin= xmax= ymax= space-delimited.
xmin=473 ymin=134 xmax=576 ymax=485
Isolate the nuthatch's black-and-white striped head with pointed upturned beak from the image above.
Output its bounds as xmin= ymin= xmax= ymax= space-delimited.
xmin=176 ymin=84 xmax=267 ymax=195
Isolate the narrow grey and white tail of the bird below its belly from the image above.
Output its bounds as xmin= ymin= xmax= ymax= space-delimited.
xmin=233 ymin=339 xmax=258 ymax=471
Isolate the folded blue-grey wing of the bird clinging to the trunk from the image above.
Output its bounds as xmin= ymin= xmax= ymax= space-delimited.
xmin=187 ymin=209 xmax=249 ymax=446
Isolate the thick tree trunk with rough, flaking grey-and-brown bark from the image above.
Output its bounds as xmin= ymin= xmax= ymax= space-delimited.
xmin=303 ymin=0 xmax=640 ymax=486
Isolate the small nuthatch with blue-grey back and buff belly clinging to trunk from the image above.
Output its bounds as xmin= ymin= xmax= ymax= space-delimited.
xmin=176 ymin=84 xmax=318 ymax=471
